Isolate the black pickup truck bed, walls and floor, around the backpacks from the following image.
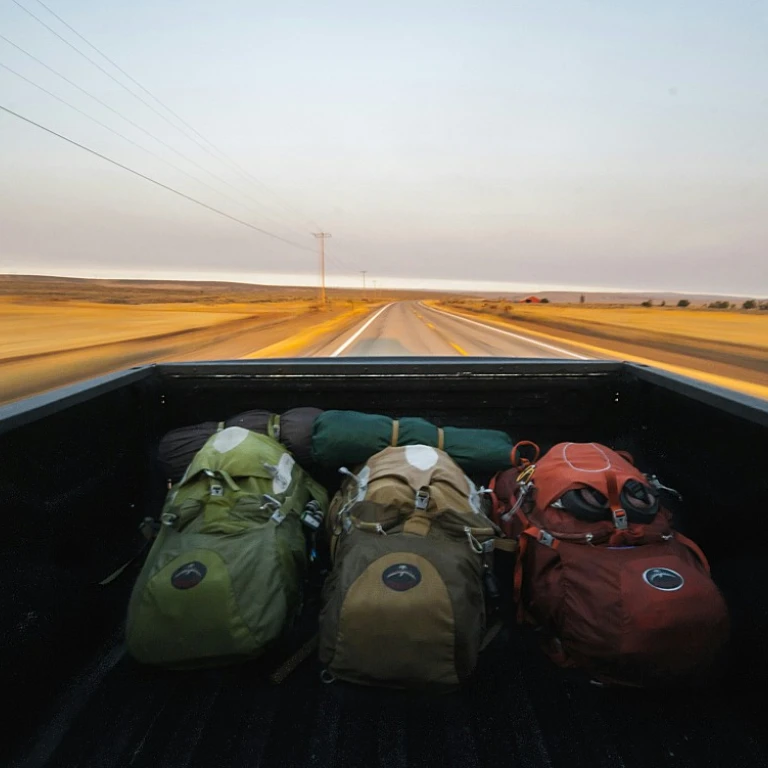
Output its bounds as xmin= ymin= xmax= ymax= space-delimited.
xmin=0 ymin=359 xmax=768 ymax=768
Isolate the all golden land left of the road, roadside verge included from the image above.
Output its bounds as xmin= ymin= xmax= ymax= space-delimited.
xmin=0 ymin=275 xmax=450 ymax=404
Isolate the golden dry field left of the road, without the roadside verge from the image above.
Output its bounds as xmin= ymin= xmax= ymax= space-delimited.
xmin=0 ymin=275 xmax=438 ymax=360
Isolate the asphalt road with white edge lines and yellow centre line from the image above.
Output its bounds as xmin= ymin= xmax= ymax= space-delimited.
xmin=304 ymin=301 xmax=588 ymax=360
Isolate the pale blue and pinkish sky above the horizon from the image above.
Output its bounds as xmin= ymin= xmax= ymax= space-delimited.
xmin=0 ymin=0 xmax=768 ymax=296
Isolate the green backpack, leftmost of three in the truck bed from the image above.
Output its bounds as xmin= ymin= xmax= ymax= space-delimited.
xmin=126 ymin=427 xmax=328 ymax=668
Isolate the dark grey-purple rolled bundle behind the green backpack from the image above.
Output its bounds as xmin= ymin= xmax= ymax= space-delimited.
xmin=158 ymin=408 xmax=322 ymax=483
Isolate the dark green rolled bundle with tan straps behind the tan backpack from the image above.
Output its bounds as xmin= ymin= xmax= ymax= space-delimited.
xmin=312 ymin=411 xmax=514 ymax=473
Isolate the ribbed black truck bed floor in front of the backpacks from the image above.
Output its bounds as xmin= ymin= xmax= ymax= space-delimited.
xmin=19 ymin=625 xmax=768 ymax=768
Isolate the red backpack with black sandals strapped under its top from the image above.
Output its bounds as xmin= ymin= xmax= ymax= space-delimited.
xmin=491 ymin=443 xmax=729 ymax=686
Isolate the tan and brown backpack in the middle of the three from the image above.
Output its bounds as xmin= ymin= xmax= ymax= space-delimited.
xmin=320 ymin=445 xmax=498 ymax=689
